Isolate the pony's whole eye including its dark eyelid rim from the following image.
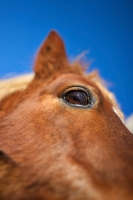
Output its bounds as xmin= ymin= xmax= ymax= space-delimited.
xmin=63 ymin=89 xmax=91 ymax=107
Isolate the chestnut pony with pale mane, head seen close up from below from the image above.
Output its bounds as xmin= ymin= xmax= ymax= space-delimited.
xmin=0 ymin=31 xmax=133 ymax=200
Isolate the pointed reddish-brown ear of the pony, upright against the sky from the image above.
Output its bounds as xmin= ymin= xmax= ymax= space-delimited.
xmin=34 ymin=31 xmax=68 ymax=79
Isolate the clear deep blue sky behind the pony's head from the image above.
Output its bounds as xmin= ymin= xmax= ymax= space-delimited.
xmin=0 ymin=0 xmax=133 ymax=116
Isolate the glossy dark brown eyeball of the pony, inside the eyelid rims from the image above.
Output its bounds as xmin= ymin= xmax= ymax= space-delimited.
xmin=65 ymin=90 xmax=88 ymax=106
